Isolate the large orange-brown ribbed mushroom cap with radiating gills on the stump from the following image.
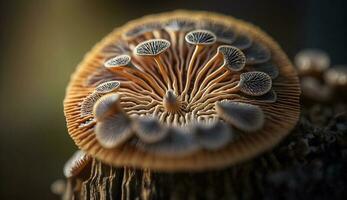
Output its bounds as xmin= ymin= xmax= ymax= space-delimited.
xmin=64 ymin=11 xmax=300 ymax=172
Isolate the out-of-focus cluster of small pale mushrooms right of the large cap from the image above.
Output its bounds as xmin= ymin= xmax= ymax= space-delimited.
xmin=295 ymin=49 xmax=347 ymax=103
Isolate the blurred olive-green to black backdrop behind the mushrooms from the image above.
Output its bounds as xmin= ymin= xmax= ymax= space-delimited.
xmin=0 ymin=0 xmax=347 ymax=199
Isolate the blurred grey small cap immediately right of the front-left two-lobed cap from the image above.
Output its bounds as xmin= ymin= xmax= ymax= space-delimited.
xmin=133 ymin=116 xmax=168 ymax=143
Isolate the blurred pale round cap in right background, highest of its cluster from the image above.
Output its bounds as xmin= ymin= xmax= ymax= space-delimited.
xmin=294 ymin=49 xmax=330 ymax=75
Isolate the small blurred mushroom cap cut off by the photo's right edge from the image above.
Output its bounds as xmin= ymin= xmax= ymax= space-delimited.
xmin=324 ymin=66 xmax=347 ymax=89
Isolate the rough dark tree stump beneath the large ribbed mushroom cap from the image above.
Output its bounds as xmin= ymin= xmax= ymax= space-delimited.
xmin=63 ymin=105 xmax=347 ymax=200
